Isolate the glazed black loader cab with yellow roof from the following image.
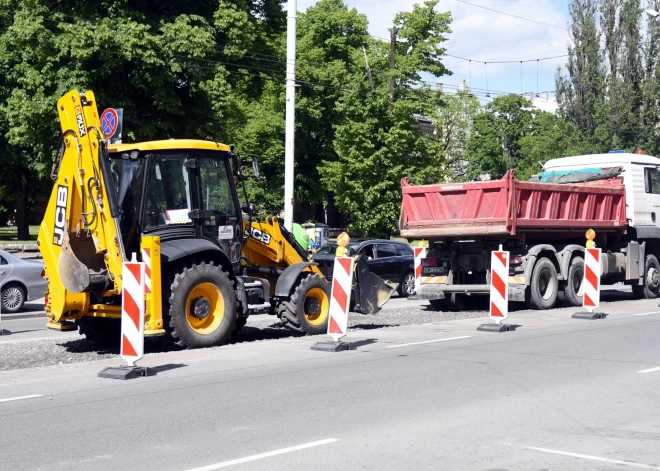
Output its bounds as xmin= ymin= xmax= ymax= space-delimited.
xmin=109 ymin=140 xmax=242 ymax=264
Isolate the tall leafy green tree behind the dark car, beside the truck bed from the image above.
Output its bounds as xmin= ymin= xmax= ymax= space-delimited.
xmin=320 ymin=0 xmax=451 ymax=236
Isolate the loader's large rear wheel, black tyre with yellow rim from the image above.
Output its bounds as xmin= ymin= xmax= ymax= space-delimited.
xmin=169 ymin=262 xmax=237 ymax=348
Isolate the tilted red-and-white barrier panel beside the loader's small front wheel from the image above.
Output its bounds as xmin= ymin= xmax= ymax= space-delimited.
xmin=328 ymin=257 xmax=355 ymax=342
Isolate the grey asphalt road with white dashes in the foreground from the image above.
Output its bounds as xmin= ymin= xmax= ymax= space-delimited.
xmin=0 ymin=294 xmax=660 ymax=471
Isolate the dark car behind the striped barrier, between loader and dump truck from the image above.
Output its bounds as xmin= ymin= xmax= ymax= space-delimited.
xmin=312 ymin=239 xmax=415 ymax=297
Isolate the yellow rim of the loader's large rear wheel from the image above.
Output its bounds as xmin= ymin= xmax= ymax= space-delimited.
xmin=186 ymin=283 xmax=225 ymax=335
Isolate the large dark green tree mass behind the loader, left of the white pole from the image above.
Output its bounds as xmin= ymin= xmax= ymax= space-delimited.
xmin=0 ymin=0 xmax=284 ymax=237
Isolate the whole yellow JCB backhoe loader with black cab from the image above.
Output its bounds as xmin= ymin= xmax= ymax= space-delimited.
xmin=38 ymin=91 xmax=391 ymax=348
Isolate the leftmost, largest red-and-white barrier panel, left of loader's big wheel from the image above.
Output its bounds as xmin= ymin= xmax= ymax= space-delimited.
xmin=121 ymin=254 xmax=146 ymax=366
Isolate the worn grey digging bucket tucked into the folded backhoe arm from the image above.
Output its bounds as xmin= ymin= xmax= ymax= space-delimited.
xmin=58 ymin=228 xmax=108 ymax=293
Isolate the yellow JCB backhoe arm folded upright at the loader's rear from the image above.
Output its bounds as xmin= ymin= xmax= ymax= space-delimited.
xmin=38 ymin=90 xmax=125 ymax=322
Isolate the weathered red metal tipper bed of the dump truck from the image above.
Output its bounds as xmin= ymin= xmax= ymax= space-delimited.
xmin=399 ymin=171 xmax=626 ymax=239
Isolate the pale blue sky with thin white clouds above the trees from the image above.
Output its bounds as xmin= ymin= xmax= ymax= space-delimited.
xmin=298 ymin=0 xmax=569 ymax=108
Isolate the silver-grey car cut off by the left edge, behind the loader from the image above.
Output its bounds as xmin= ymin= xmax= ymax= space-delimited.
xmin=0 ymin=250 xmax=47 ymax=313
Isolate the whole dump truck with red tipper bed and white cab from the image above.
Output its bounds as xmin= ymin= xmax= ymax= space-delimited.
xmin=399 ymin=153 xmax=660 ymax=310
